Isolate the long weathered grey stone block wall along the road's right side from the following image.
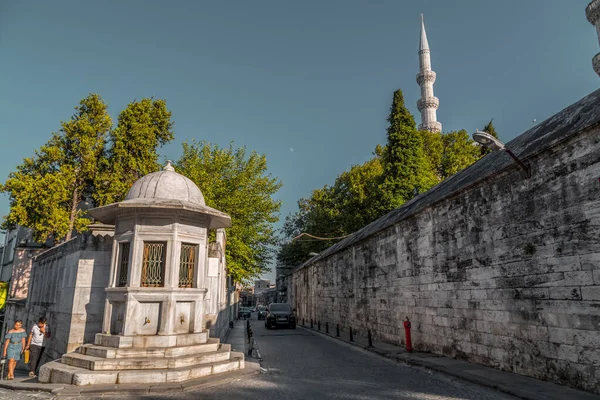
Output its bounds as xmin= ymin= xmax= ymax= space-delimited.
xmin=288 ymin=91 xmax=600 ymax=393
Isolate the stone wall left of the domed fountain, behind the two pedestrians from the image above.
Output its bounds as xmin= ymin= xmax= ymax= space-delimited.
xmin=15 ymin=225 xmax=112 ymax=359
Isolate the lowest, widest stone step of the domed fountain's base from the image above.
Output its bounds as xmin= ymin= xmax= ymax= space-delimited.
xmin=38 ymin=352 xmax=245 ymax=386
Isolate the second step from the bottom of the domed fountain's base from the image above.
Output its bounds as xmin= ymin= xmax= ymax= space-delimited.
xmin=61 ymin=349 xmax=230 ymax=371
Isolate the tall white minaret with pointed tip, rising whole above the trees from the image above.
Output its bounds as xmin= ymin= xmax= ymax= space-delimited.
xmin=417 ymin=14 xmax=442 ymax=132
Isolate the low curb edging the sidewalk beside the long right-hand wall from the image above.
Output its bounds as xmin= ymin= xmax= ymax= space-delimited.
xmin=298 ymin=325 xmax=600 ymax=400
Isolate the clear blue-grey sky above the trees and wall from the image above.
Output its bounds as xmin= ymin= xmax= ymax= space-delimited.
xmin=0 ymin=0 xmax=599 ymax=278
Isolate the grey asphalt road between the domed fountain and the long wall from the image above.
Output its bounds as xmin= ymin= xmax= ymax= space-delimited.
xmin=36 ymin=316 xmax=514 ymax=400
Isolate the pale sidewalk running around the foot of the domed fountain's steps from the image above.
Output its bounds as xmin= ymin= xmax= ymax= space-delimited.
xmin=0 ymin=320 xmax=260 ymax=396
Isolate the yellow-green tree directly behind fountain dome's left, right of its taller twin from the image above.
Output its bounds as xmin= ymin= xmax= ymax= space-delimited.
xmin=93 ymin=98 xmax=174 ymax=205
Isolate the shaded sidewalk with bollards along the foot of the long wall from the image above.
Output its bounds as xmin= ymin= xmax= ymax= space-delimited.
xmin=298 ymin=323 xmax=600 ymax=400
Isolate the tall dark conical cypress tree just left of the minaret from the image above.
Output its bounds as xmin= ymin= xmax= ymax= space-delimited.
xmin=381 ymin=90 xmax=438 ymax=211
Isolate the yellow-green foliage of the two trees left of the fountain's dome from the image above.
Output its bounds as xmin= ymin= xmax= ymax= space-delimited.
xmin=0 ymin=94 xmax=173 ymax=242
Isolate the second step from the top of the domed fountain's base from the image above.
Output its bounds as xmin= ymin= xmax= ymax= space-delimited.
xmin=77 ymin=338 xmax=231 ymax=358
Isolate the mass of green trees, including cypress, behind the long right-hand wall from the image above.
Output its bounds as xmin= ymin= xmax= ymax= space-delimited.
xmin=277 ymin=90 xmax=495 ymax=265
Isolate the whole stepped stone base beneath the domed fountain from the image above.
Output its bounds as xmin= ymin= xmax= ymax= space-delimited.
xmin=38 ymin=332 xmax=244 ymax=386
